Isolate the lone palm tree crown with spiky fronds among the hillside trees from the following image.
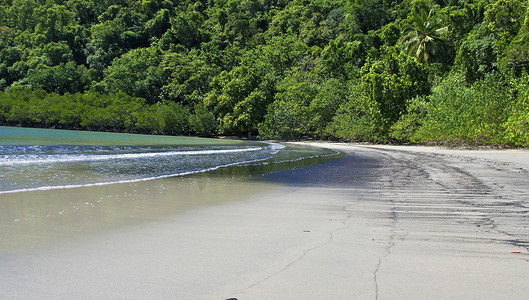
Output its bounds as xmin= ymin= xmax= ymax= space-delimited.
xmin=400 ymin=9 xmax=448 ymax=63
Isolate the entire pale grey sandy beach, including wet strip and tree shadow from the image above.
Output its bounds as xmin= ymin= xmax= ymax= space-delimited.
xmin=0 ymin=143 xmax=529 ymax=300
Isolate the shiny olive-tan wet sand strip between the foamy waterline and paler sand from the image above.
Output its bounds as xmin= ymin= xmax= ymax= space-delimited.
xmin=0 ymin=174 xmax=278 ymax=254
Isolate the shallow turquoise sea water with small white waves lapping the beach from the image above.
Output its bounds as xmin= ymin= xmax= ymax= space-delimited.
xmin=0 ymin=126 xmax=337 ymax=194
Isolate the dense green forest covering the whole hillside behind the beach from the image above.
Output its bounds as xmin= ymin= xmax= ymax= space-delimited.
xmin=0 ymin=0 xmax=529 ymax=146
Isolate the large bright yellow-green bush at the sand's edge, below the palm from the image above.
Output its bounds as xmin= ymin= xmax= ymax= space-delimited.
xmin=412 ymin=73 xmax=512 ymax=145
